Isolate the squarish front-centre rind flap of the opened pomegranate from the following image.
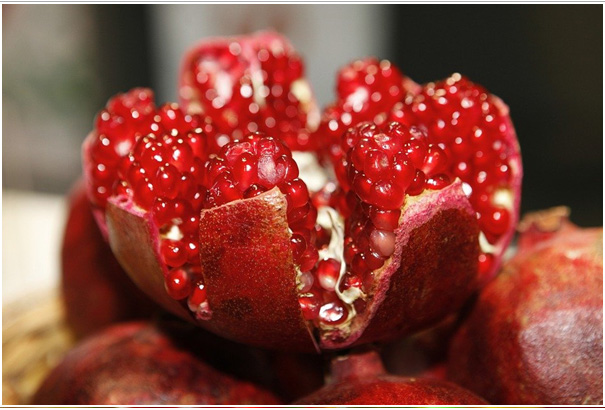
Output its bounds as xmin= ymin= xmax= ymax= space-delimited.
xmin=200 ymin=188 xmax=317 ymax=351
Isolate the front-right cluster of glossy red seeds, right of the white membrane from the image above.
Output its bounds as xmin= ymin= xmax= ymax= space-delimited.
xmin=332 ymin=122 xmax=451 ymax=293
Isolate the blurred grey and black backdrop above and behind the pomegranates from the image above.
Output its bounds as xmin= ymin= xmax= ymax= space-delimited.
xmin=2 ymin=4 xmax=603 ymax=226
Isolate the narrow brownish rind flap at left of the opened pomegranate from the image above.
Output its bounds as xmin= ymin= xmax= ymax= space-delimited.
xmin=106 ymin=196 xmax=193 ymax=321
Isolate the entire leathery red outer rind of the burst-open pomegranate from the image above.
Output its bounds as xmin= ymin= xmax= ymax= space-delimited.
xmin=107 ymin=176 xmax=479 ymax=352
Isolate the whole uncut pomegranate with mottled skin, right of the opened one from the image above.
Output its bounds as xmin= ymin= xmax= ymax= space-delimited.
xmin=448 ymin=208 xmax=603 ymax=405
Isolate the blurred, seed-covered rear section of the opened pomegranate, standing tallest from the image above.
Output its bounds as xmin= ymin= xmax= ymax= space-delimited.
xmin=179 ymin=31 xmax=319 ymax=151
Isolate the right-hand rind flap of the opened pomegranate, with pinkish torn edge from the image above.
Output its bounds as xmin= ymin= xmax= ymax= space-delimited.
xmin=321 ymin=180 xmax=479 ymax=349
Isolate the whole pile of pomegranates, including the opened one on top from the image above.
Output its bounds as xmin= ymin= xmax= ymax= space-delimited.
xmin=35 ymin=32 xmax=602 ymax=405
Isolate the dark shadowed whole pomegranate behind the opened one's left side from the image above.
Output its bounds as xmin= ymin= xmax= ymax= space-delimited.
xmin=61 ymin=180 xmax=157 ymax=337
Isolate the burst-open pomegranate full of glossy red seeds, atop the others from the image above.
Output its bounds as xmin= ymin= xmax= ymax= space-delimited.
xmin=83 ymin=32 xmax=521 ymax=351
